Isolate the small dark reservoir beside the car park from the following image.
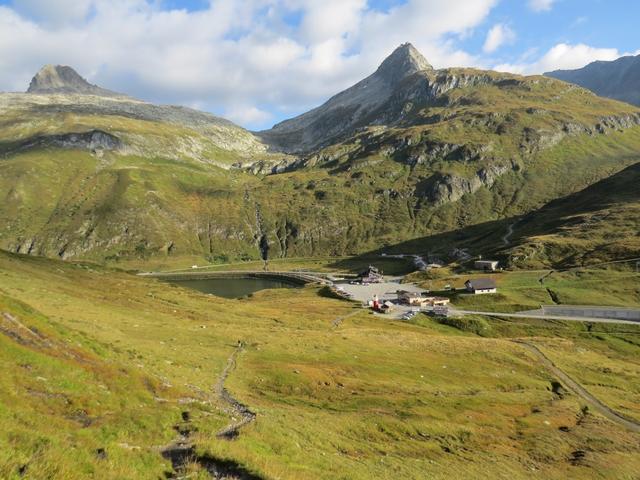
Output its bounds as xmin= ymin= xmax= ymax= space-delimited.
xmin=171 ymin=277 xmax=301 ymax=298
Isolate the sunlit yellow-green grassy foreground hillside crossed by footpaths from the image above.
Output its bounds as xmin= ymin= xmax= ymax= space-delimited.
xmin=0 ymin=249 xmax=640 ymax=479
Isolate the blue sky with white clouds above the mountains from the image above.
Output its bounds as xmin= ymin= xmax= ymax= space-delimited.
xmin=0 ymin=0 xmax=640 ymax=130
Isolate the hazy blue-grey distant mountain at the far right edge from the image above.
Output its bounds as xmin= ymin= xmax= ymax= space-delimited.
xmin=545 ymin=55 xmax=640 ymax=106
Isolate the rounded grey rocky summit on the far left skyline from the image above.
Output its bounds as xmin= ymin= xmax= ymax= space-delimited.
xmin=27 ymin=65 xmax=119 ymax=97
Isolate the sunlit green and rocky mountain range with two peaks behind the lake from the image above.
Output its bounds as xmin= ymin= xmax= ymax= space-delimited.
xmin=0 ymin=44 xmax=640 ymax=263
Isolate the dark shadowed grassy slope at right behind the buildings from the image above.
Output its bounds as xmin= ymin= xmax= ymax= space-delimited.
xmin=376 ymin=163 xmax=640 ymax=268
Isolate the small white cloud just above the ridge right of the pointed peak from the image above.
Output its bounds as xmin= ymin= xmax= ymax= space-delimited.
xmin=494 ymin=43 xmax=624 ymax=74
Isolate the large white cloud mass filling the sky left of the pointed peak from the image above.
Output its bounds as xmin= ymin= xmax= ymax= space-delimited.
xmin=0 ymin=0 xmax=499 ymax=128
